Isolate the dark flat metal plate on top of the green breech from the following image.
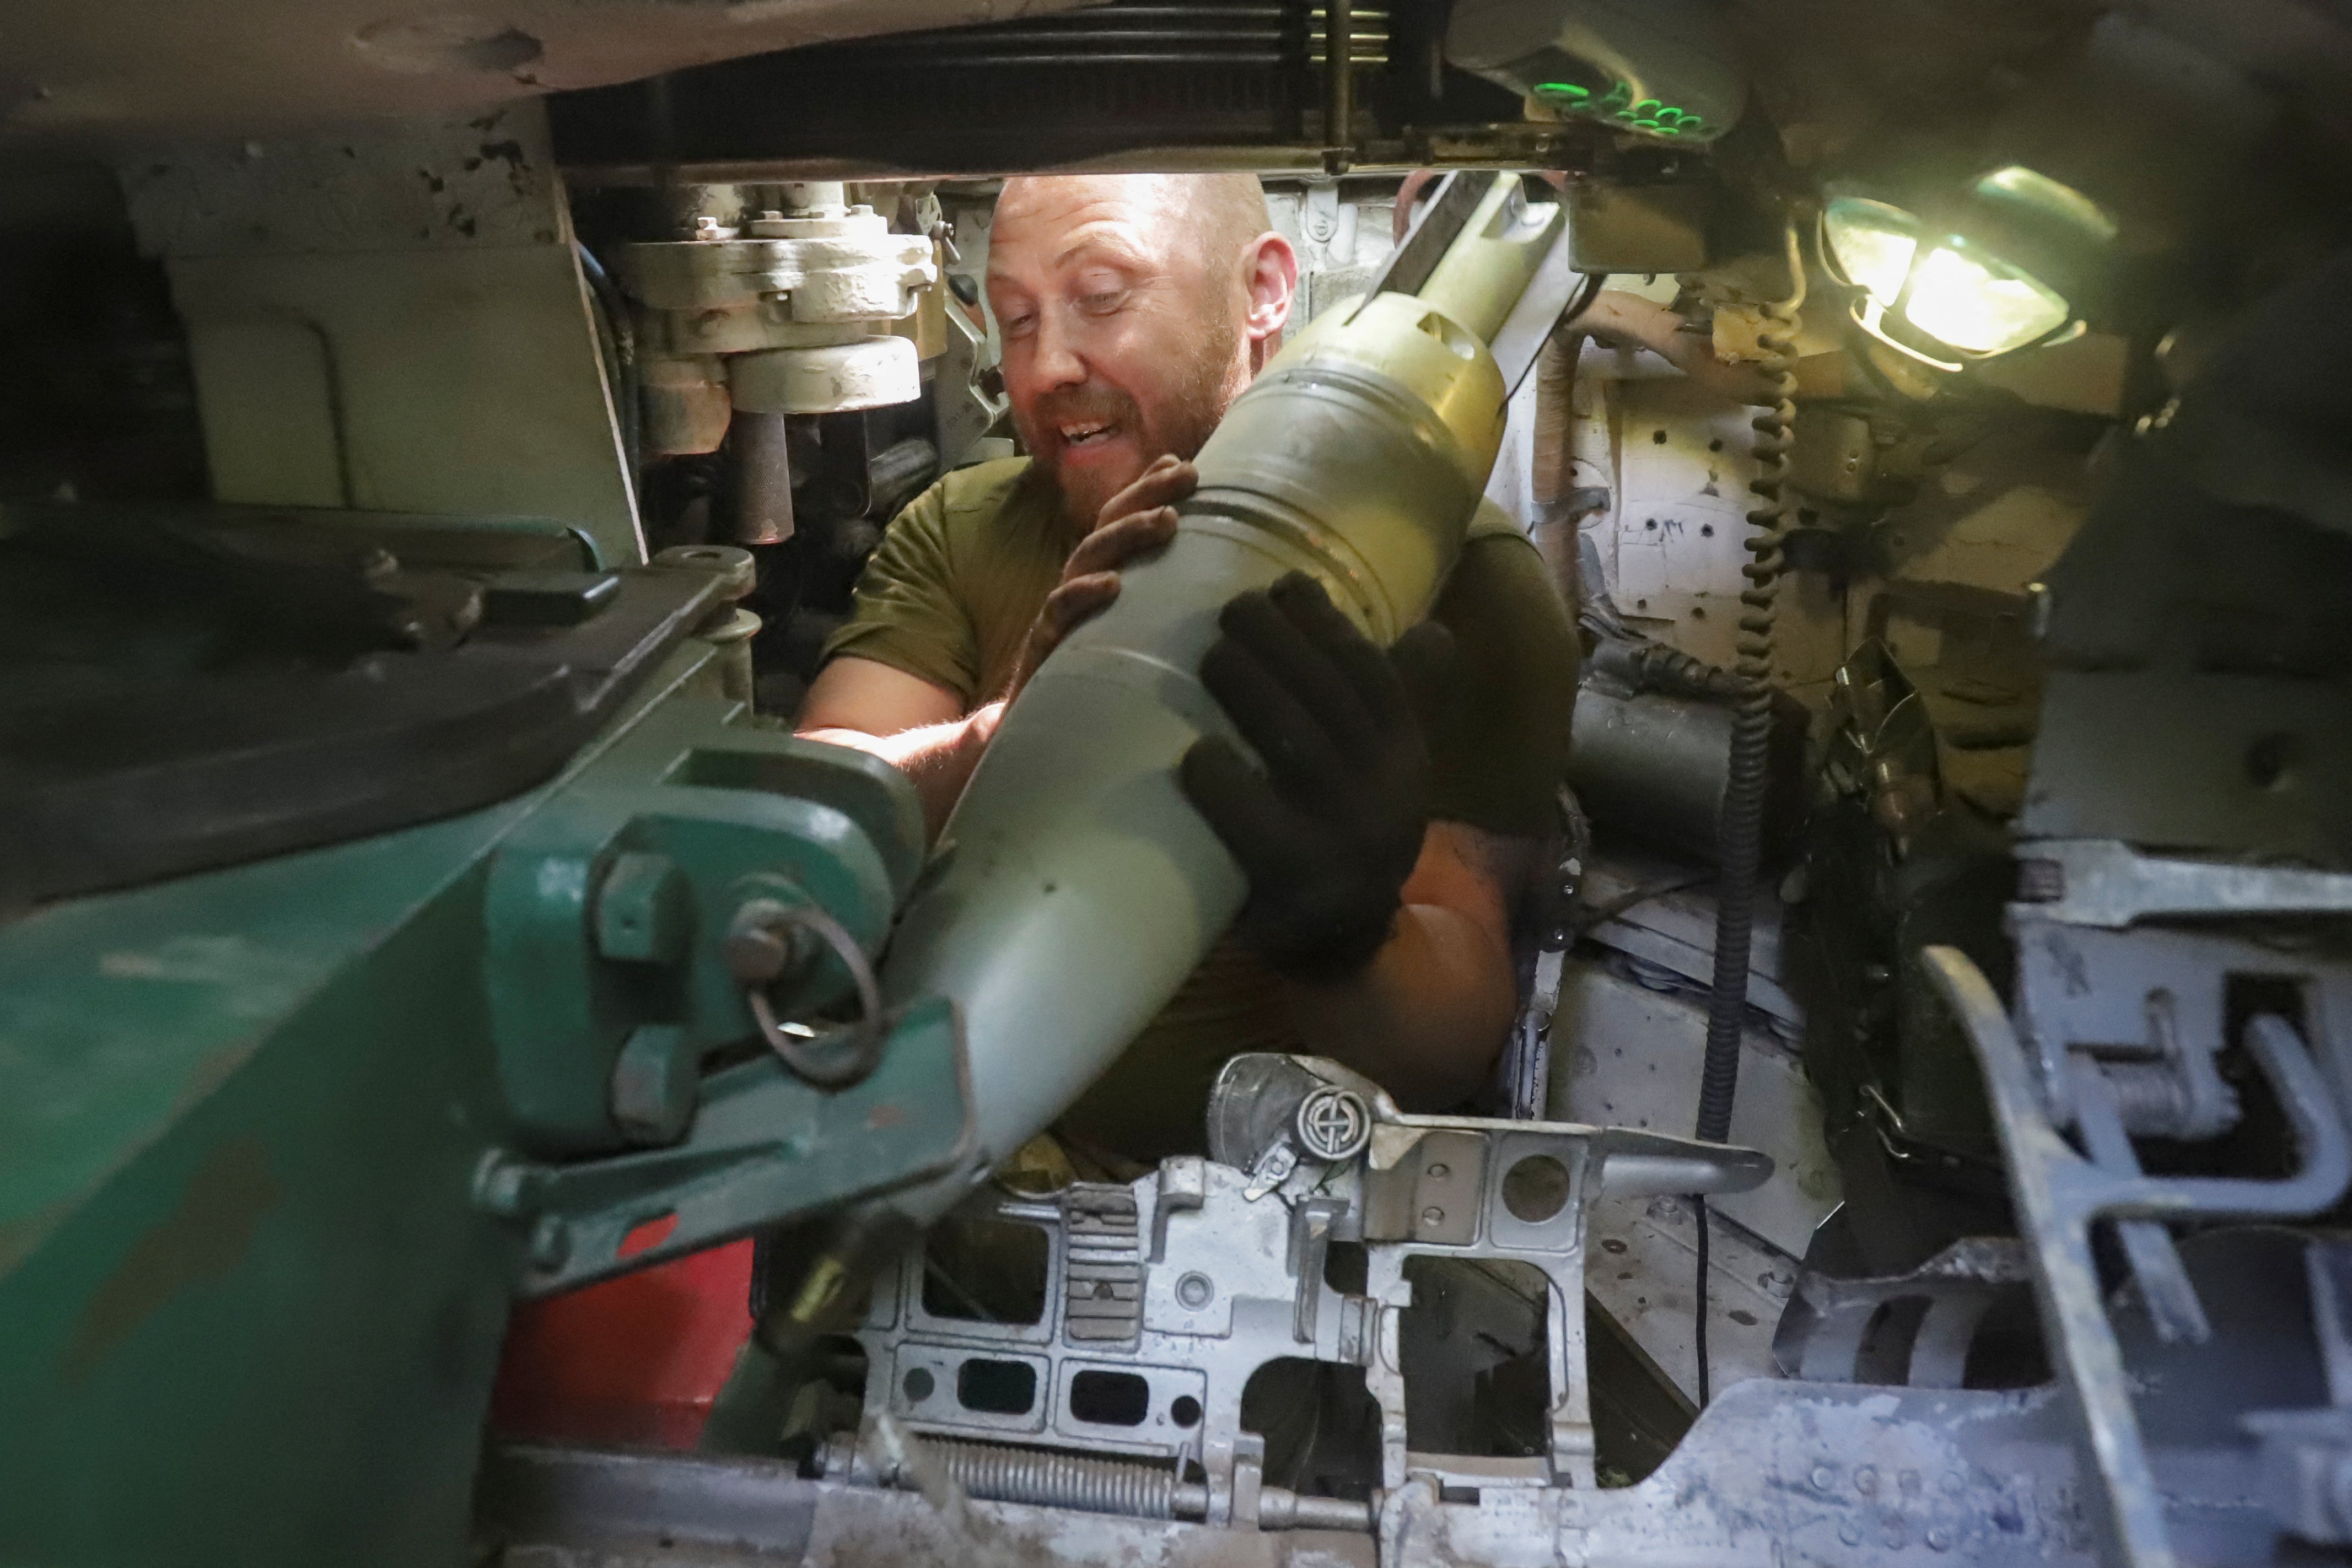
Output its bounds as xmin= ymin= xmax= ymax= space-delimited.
xmin=0 ymin=503 xmax=691 ymax=910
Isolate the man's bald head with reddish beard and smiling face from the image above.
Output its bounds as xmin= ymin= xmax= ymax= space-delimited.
xmin=988 ymin=174 xmax=1298 ymax=524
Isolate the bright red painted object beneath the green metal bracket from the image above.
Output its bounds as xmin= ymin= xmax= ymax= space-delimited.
xmin=489 ymin=1217 xmax=752 ymax=1448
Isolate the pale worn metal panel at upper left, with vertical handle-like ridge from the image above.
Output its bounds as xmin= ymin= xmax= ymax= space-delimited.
xmin=117 ymin=104 xmax=644 ymax=564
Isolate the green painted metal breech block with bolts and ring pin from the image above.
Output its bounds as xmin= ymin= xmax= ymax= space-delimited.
xmin=0 ymin=644 xmax=969 ymax=1566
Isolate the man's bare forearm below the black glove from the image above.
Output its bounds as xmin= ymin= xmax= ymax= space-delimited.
xmin=1284 ymin=823 xmax=1522 ymax=1112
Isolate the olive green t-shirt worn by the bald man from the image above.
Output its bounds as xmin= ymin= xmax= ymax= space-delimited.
xmin=826 ymin=459 xmax=1578 ymax=1159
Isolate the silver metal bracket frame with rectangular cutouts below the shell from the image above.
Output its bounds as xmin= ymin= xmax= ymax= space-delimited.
xmin=828 ymin=1055 xmax=1769 ymax=1528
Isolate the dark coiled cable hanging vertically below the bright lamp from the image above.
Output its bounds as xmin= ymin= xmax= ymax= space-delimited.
xmin=1698 ymin=223 xmax=1804 ymax=1143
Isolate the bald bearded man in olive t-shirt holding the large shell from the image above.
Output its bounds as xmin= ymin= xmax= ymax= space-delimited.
xmin=800 ymin=174 xmax=1578 ymax=1178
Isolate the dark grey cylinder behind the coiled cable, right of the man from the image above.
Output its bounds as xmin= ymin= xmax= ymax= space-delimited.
xmin=1569 ymin=682 xmax=1804 ymax=863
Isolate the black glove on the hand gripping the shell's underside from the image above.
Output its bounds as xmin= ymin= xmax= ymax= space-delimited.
xmin=1178 ymin=571 xmax=1454 ymax=980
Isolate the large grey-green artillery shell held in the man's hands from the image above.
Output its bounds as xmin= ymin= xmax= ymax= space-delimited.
xmin=884 ymin=294 xmax=1505 ymax=1217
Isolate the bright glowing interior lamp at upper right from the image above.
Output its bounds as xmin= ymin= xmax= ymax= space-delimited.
xmin=1821 ymin=167 xmax=2114 ymax=369
